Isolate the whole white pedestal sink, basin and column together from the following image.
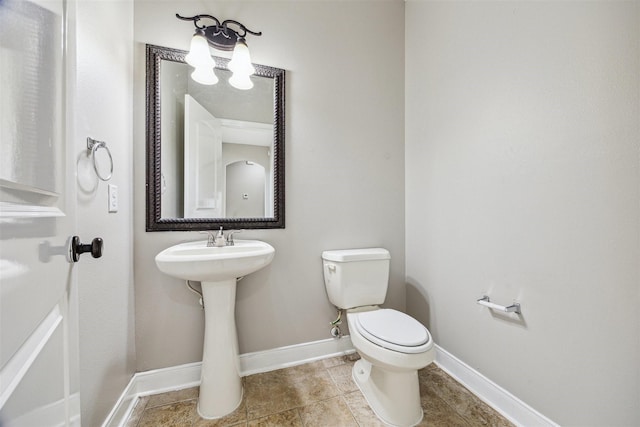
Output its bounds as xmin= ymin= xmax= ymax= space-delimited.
xmin=156 ymin=240 xmax=275 ymax=419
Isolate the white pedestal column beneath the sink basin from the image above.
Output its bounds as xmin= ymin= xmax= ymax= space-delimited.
xmin=198 ymin=278 xmax=242 ymax=419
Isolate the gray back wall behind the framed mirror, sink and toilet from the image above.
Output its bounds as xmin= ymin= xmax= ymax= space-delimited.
xmin=134 ymin=0 xmax=405 ymax=371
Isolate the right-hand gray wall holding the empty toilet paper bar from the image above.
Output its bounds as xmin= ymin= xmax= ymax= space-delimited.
xmin=405 ymin=1 xmax=640 ymax=426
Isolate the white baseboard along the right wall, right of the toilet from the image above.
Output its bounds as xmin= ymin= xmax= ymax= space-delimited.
xmin=436 ymin=345 xmax=558 ymax=427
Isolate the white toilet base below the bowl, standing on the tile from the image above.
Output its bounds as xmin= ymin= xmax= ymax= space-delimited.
xmin=353 ymin=359 xmax=423 ymax=427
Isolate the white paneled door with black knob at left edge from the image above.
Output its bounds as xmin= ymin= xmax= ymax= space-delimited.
xmin=0 ymin=0 xmax=82 ymax=427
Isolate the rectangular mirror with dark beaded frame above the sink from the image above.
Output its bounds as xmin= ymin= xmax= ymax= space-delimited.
xmin=146 ymin=45 xmax=284 ymax=231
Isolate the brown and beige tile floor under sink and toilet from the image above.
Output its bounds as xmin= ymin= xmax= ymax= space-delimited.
xmin=125 ymin=354 xmax=512 ymax=427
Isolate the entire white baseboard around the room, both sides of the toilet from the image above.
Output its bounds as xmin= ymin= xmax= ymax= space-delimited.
xmin=102 ymin=336 xmax=558 ymax=427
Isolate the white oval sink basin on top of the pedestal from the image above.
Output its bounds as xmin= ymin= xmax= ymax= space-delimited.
xmin=156 ymin=240 xmax=275 ymax=282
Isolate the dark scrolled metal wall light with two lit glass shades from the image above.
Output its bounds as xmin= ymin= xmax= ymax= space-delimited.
xmin=176 ymin=13 xmax=262 ymax=90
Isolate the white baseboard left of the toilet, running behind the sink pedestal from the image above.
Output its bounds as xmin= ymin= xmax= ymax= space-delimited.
xmin=102 ymin=336 xmax=355 ymax=427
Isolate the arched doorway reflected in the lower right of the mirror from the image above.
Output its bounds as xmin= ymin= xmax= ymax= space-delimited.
xmin=225 ymin=160 xmax=266 ymax=218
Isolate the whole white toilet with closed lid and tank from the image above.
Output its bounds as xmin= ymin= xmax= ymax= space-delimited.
xmin=322 ymin=248 xmax=435 ymax=427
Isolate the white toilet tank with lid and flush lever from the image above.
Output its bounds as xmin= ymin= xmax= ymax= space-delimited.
xmin=322 ymin=248 xmax=391 ymax=309
